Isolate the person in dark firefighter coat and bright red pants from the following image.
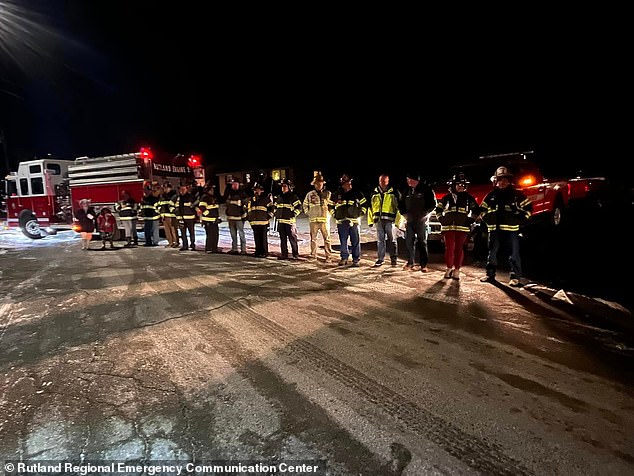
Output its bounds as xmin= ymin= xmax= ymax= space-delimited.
xmin=435 ymin=172 xmax=478 ymax=279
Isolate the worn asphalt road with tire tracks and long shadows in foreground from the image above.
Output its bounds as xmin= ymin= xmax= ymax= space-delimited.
xmin=0 ymin=242 xmax=634 ymax=475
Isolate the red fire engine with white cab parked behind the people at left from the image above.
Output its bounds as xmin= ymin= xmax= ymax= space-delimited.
xmin=5 ymin=148 xmax=205 ymax=239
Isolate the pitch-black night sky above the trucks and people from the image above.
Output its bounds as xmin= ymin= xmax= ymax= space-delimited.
xmin=0 ymin=0 xmax=631 ymax=184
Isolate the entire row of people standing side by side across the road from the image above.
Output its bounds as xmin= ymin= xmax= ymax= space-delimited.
xmin=76 ymin=167 xmax=531 ymax=286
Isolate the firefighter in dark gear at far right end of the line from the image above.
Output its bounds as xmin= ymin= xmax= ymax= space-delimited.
xmin=478 ymin=167 xmax=532 ymax=287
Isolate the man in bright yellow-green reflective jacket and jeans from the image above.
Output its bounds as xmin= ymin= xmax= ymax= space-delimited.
xmin=368 ymin=174 xmax=401 ymax=268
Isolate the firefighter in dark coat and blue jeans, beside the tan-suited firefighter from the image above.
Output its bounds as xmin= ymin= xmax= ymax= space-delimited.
xmin=331 ymin=174 xmax=367 ymax=267
